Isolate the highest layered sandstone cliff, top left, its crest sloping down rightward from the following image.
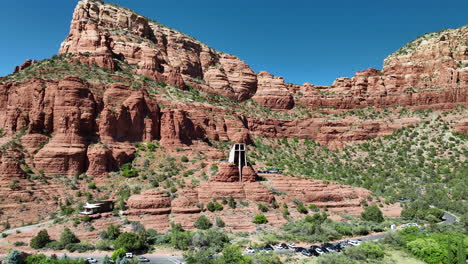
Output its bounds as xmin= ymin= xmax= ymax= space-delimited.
xmin=59 ymin=0 xmax=257 ymax=101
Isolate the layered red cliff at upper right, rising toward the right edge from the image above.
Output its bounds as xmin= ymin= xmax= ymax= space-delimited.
xmin=298 ymin=26 xmax=468 ymax=109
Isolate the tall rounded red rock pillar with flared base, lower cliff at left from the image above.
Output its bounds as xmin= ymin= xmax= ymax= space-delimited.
xmin=34 ymin=77 xmax=96 ymax=175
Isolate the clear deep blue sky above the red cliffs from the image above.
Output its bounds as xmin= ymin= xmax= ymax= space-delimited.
xmin=0 ymin=0 xmax=468 ymax=85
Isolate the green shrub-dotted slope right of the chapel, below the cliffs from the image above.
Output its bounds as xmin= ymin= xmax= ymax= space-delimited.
xmin=250 ymin=109 xmax=468 ymax=213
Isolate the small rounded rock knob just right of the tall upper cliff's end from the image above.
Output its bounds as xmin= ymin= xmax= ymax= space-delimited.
xmin=252 ymin=72 xmax=294 ymax=109
